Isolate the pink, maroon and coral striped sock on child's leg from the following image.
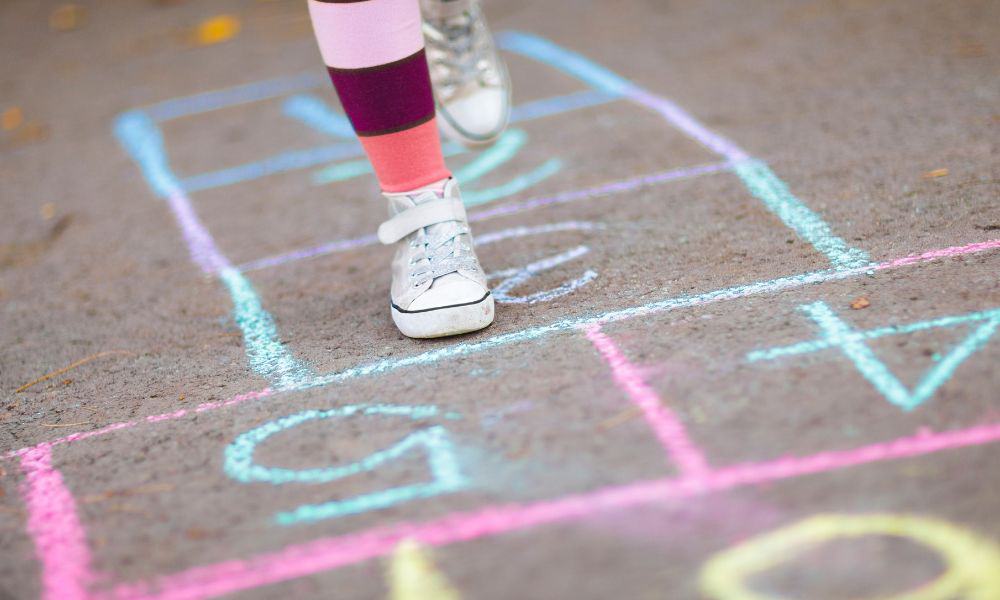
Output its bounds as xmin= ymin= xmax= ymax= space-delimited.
xmin=309 ymin=0 xmax=450 ymax=192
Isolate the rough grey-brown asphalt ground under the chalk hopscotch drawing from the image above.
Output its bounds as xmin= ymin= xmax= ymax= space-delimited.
xmin=0 ymin=0 xmax=1000 ymax=600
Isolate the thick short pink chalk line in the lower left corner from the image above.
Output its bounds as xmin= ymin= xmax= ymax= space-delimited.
xmin=21 ymin=444 xmax=94 ymax=600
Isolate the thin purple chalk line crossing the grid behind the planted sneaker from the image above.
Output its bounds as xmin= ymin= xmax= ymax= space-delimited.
xmin=237 ymin=162 xmax=732 ymax=272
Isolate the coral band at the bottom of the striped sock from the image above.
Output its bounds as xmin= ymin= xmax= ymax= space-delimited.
xmin=361 ymin=118 xmax=451 ymax=192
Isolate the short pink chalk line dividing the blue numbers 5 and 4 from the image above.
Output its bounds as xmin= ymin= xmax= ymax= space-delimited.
xmin=584 ymin=323 xmax=709 ymax=476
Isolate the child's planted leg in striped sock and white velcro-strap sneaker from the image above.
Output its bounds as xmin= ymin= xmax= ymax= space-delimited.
xmin=309 ymin=0 xmax=493 ymax=338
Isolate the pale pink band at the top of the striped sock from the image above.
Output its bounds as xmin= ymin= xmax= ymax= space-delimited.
xmin=309 ymin=0 xmax=424 ymax=69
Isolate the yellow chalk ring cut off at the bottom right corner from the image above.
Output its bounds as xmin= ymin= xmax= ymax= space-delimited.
xmin=700 ymin=514 xmax=1000 ymax=600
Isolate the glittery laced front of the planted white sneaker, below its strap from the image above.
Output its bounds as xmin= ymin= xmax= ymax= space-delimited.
xmin=410 ymin=222 xmax=479 ymax=287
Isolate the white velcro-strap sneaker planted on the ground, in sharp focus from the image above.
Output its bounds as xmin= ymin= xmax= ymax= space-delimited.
xmin=378 ymin=179 xmax=493 ymax=338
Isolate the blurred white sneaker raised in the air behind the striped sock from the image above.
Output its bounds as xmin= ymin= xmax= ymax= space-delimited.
xmin=421 ymin=0 xmax=510 ymax=146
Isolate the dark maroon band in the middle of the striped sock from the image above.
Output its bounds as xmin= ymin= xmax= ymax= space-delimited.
xmin=327 ymin=49 xmax=434 ymax=136
